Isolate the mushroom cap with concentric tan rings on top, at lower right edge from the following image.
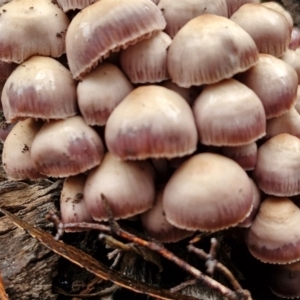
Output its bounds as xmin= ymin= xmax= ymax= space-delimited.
xmin=246 ymin=197 xmax=300 ymax=264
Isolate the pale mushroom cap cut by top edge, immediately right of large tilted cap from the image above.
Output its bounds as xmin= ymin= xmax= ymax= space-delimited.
xmin=157 ymin=0 xmax=228 ymax=38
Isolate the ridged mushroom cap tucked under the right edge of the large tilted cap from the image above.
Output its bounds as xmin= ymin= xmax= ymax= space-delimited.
xmin=120 ymin=31 xmax=172 ymax=83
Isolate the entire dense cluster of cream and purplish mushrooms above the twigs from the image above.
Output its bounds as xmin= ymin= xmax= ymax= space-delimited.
xmin=0 ymin=0 xmax=300 ymax=298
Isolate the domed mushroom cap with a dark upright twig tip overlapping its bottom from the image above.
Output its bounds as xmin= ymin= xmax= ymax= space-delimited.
xmin=84 ymin=152 xmax=155 ymax=221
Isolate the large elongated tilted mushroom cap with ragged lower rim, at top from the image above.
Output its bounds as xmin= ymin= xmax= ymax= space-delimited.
xmin=66 ymin=0 xmax=166 ymax=79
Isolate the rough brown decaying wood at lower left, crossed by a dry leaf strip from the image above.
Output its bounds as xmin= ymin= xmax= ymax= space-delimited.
xmin=0 ymin=175 xmax=60 ymax=300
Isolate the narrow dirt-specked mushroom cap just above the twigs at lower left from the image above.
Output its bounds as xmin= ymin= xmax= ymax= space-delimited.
xmin=60 ymin=174 xmax=93 ymax=232
